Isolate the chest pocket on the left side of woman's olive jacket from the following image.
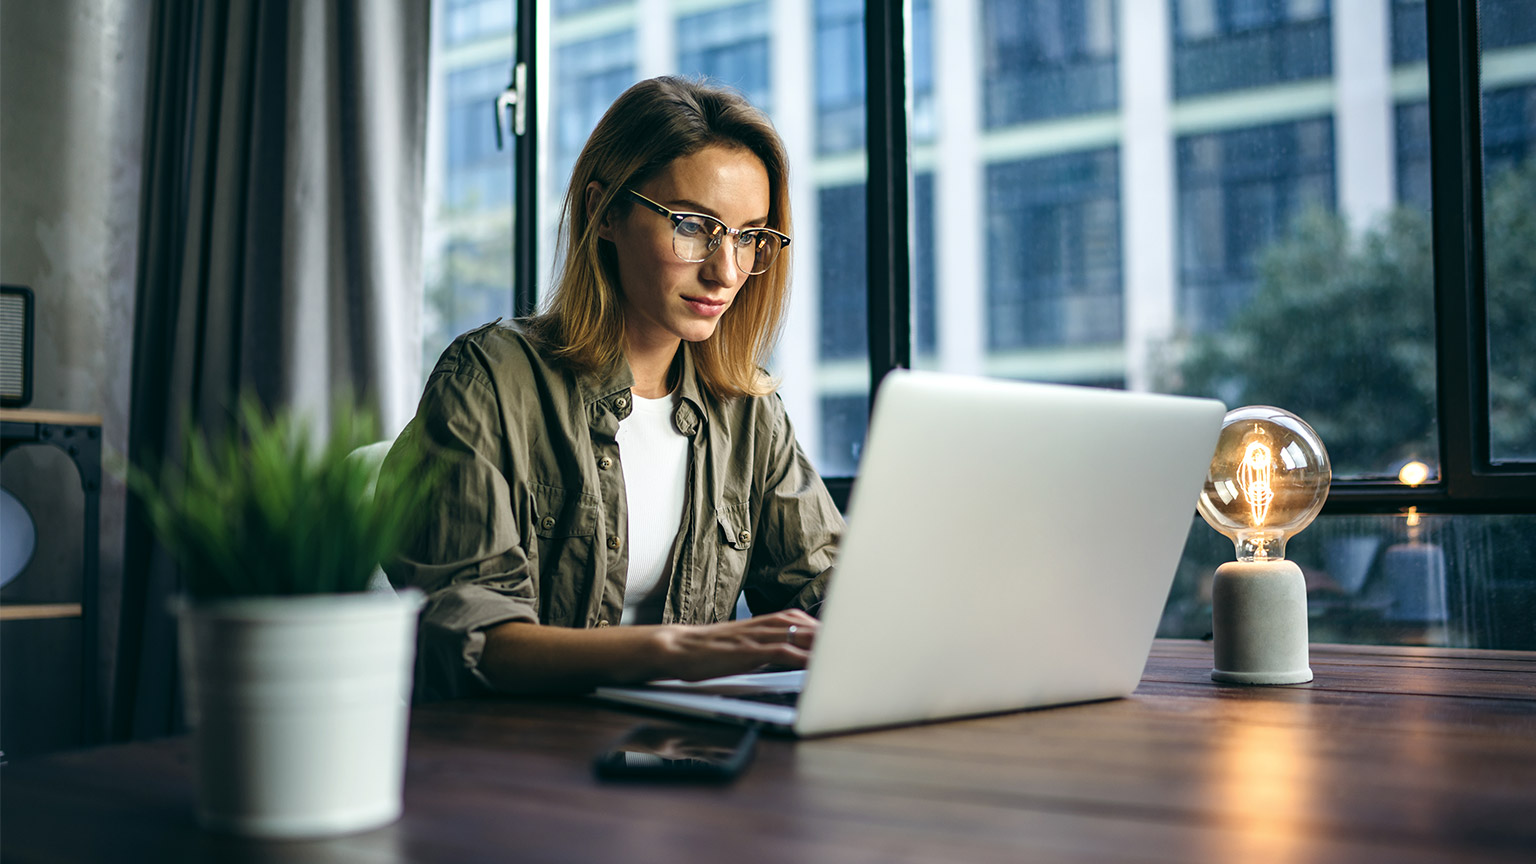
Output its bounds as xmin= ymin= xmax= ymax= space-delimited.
xmin=528 ymin=483 xmax=598 ymax=626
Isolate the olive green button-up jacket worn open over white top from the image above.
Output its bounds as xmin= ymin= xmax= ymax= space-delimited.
xmin=384 ymin=323 xmax=843 ymax=698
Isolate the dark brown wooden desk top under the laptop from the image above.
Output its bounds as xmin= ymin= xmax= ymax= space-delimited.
xmin=0 ymin=641 xmax=1536 ymax=864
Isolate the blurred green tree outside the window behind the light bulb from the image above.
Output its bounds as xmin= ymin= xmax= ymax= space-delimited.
xmin=1164 ymin=164 xmax=1536 ymax=477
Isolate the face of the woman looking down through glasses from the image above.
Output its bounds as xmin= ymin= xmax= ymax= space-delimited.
xmin=598 ymin=145 xmax=768 ymax=351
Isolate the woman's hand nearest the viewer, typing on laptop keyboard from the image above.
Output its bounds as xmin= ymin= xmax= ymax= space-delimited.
xmin=660 ymin=609 xmax=820 ymax=681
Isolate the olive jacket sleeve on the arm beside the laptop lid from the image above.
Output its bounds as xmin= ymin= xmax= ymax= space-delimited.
xmin=745 ymin=397 xmax=843 ymax=615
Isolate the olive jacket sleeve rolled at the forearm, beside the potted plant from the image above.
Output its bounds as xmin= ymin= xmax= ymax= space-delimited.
xmin=384 ymin=363 xmax=539 ymax=700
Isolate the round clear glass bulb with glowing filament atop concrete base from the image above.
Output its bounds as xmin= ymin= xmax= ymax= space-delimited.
xmin=1198 ymin=406 xmax=1333 ymax=561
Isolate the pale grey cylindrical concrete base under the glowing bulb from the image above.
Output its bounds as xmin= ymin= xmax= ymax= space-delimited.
xmin=1210 ymin=561 xmax=1312 ymax=684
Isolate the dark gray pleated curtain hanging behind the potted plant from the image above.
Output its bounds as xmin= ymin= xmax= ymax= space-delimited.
xmin=114 ymin=0 xmax=430 ymax=738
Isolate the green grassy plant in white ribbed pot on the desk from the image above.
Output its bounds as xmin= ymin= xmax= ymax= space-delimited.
xmin=129 ymin=401 xmax=422 ymax=838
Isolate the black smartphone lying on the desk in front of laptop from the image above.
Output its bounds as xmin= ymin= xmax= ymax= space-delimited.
xmin=591 ymin=723 xmax=757 ymax=783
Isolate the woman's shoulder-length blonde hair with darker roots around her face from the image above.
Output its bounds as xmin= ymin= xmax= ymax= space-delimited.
xmin=528 ymin=77 xmax=793 ymax=398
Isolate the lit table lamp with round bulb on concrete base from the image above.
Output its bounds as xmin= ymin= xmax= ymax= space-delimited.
xmin=1198 ymin=406 xmax=1333 ymax=684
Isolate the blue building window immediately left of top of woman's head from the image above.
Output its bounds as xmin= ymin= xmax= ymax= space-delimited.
xmin=551 ymin=31 xmax=634 ymax=184
